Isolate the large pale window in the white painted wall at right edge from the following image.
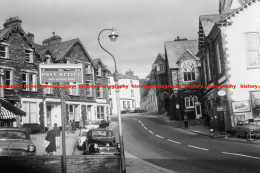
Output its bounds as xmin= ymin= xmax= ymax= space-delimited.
xmin=245 ymin=33 xmax=260 ymax=67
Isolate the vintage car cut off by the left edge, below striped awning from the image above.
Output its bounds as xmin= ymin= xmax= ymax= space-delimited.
xmin=0 ymin=127 xmax=36 ymax=156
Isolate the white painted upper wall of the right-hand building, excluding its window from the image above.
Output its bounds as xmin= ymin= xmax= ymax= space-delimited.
xmin=222 ymin=1 xmax=260 ymax=119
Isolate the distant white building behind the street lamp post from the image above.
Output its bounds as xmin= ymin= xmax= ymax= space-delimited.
xmin=108 ymin=70 xmax=141 ymax=115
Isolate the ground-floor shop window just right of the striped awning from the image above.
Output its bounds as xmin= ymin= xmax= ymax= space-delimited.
xmin=22 ymin=102 xmax=39 ymax=123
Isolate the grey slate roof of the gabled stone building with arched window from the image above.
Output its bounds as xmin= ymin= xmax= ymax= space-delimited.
xmin=164 ymin=40 xmax=198 ymax=68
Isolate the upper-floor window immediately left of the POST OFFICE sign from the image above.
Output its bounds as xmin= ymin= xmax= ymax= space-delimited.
xmin=22 ymin=72 xmax=37 ymax=91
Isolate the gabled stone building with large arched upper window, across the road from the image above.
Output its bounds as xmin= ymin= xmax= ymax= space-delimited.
xmin=164 ymin=37 xmax=202 ymax=120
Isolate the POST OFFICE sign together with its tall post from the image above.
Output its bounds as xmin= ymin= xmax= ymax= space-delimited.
xmin=39 ymin=64 xmax=83 ymax=173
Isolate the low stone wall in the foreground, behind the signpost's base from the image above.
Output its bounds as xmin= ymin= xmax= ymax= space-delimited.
xmin=0 ymin=156 xmax=119 ymax=173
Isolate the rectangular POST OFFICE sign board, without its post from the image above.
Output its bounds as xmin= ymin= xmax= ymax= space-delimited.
xmin=39 ymin=64 xmax=83 ymax=85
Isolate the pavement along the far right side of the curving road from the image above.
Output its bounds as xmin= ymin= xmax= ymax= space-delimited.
xmin=150 ymin=113 xmax=260 ymax=144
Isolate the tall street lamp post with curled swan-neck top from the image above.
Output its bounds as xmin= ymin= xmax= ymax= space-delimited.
xmin=98 ymin=28 xmax=126 ymax=173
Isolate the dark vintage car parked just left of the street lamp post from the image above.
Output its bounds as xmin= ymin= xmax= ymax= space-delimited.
xmin=82 ymin=128 xmax=120 ymax=155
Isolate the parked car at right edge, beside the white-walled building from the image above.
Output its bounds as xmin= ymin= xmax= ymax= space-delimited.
xmin=235 ymin=121 xmax=260 ymax=138
